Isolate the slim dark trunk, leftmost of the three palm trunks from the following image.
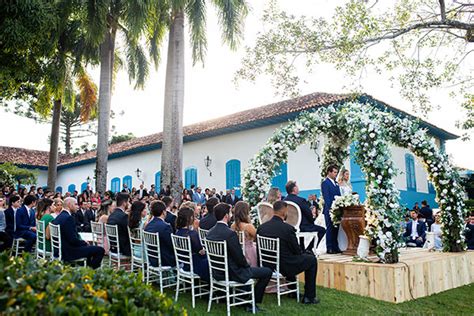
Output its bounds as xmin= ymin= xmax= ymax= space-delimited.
xmin=48 ymin=100 xmax=62 ymax=191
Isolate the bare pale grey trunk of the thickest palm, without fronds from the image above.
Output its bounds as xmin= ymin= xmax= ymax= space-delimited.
xmin=161 ymin=12 xmax=184 ymax=202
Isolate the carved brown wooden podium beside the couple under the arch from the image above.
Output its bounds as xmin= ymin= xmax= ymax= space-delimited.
xmin=341 ymin=205 xmax=365 ymax=256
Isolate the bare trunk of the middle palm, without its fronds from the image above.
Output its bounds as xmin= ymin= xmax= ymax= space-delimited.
xmin=96 ymin=29 xmax=116 ymax=194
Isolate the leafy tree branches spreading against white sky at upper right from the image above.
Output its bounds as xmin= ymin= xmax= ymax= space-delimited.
xmin=236 ymin=0 xmax=474 ymax=135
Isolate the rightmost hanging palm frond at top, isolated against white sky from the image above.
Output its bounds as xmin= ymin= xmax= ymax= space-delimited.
xmin=212 ymin=0 xmax=248 ymax=50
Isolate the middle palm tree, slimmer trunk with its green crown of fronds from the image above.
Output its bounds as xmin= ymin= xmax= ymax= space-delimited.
xmin=85 ymin=0 xmax=153 ymax=192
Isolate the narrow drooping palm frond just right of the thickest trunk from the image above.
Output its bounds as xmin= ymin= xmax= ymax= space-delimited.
xmin=186 ymin=0 xmax=207 ymax=65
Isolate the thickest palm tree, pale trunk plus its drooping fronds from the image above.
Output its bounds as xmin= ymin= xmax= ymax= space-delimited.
xmin=150 ymin=0 xmax=248 ymax=200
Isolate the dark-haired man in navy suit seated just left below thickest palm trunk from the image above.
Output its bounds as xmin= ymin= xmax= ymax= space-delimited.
xmin=145 ymin=201 xmax=176 ymax=267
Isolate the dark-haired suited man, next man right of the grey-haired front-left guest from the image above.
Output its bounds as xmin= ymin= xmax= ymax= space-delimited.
xmin=107 ymin=192 xmax=131 ymax=256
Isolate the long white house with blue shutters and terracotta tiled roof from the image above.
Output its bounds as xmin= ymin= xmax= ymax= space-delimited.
xmin=0 ymin=93 xmax=457 ymax=207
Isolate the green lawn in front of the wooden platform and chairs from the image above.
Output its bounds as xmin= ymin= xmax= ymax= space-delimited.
xmin=166 ymin=283 xmax=474 ymax=316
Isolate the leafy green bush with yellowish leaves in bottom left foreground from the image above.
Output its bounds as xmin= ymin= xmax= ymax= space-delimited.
xmin=0 ymin=254 xmax=186 ymax=315
